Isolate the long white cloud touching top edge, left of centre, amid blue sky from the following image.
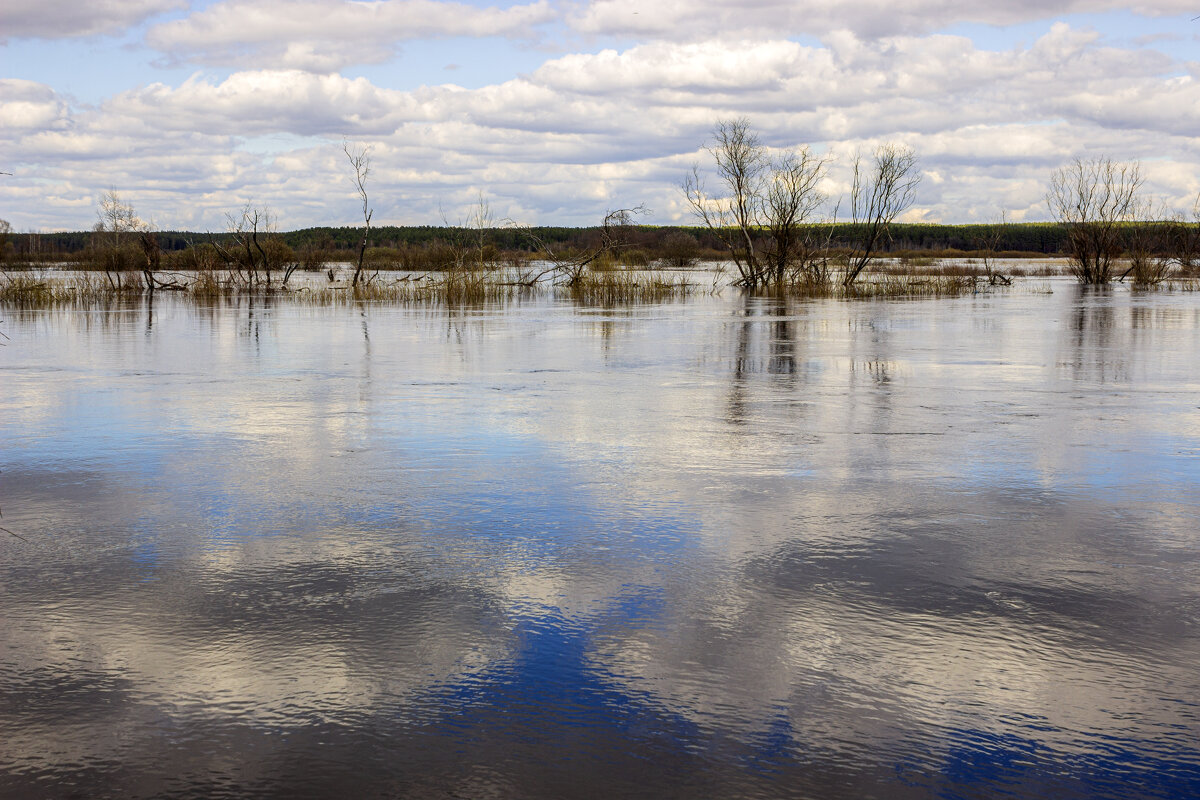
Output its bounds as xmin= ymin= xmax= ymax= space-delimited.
xmin=146 ymin=0 xmax=558 ymax=72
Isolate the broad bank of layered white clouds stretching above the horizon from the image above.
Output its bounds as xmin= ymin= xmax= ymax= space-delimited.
xmin=7 ymin=24 xmax=1200 ymax=227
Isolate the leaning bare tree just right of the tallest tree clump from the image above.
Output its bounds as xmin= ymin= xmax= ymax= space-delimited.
xmin=842 ymin=143 xmax=920 ymax=287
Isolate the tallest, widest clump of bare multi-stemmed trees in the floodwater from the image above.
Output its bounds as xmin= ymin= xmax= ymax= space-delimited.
xmin=682 ymin=118 xmax=827 ymax=288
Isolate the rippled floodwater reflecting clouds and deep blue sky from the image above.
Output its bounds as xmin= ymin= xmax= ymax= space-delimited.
xmin=0 ymin=283 xmax=1200 ymax=799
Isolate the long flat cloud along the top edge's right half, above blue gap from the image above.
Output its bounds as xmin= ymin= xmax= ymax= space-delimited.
xmin=569 ymin=0 xmax=1194 ymax=41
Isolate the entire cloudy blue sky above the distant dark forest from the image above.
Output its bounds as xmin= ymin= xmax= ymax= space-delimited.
xmin=0 ymin=0 xmax=1200 ymax=230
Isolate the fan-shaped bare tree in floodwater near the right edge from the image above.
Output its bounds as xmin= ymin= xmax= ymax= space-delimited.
xmin=1046 ymin=156 xmax=1142 ymax=284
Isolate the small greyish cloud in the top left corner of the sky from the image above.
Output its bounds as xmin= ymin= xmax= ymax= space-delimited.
xmin=0 ymin=0 xmax=187 ymax=42
